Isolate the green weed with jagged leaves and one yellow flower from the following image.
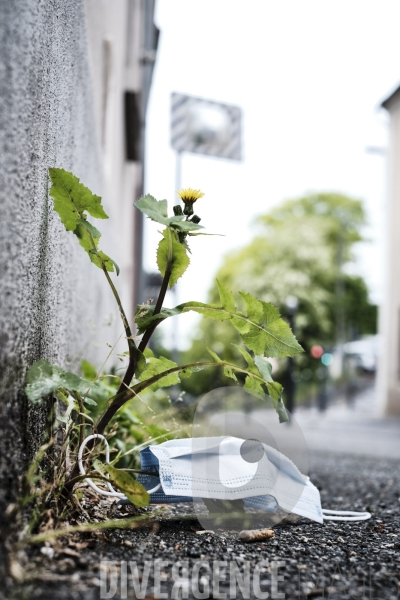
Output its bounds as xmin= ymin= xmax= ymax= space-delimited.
xmin=25 ymin=168 xmax=302 ymax=507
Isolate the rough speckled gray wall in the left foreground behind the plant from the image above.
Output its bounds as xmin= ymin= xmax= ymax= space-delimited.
xmin=0 ymin=0 xmax=114 ymax=562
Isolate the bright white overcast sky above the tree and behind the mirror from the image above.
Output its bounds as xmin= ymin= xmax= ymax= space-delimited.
xmin=146 ymin=0 xmax=400 ymax=350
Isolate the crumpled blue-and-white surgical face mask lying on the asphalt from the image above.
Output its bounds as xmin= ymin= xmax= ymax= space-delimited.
xmin=138 ymin=436 xmax=371 ymax=528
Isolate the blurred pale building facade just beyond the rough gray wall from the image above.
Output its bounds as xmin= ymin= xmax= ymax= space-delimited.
xmin=84 ymin=0 xmax=159 ymax=312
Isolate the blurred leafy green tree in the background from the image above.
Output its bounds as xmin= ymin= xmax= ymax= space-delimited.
xmin=184 ymin=193 xmax=377 ymax=395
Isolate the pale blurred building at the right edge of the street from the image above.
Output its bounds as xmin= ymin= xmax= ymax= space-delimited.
xmin=378 ymin=86 xmax=400 ymax=416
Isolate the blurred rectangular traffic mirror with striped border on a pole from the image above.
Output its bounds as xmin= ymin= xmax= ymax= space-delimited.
xmin=171 ymin=92 xmax=242 ymax=160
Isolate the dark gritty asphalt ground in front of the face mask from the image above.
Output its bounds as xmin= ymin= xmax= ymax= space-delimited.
xmin=7 ymin=453 xmax=400 ymax=600
